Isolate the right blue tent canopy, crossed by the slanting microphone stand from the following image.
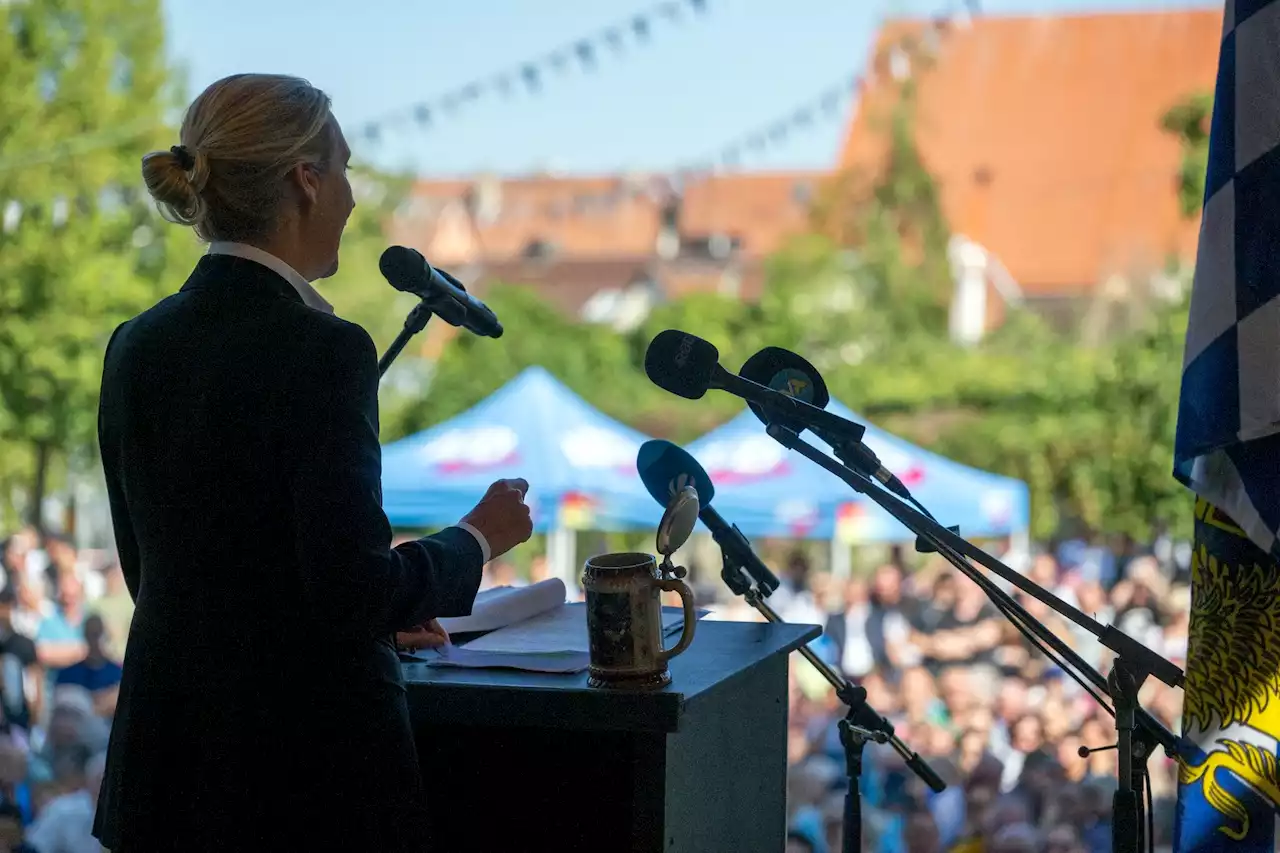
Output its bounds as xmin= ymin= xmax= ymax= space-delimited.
xmin=689 ymin=401 xmax=1030 ymax=542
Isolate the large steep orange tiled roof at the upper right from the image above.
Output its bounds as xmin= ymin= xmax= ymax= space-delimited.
xmin=841 ymin=6 xmax=1222 ymax=295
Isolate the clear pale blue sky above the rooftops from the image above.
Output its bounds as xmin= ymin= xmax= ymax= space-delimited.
xmin=165 ymin=0 xmax=1215 ymax=175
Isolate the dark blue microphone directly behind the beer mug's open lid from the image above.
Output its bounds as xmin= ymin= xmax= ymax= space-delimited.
xmin=636 ymin=439 xmax=778 ymax=597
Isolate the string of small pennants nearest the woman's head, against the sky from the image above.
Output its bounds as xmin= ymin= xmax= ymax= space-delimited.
xmin=357 ymin=0 xmax=708 ymax=142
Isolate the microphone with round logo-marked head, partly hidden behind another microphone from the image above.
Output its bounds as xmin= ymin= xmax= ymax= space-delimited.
xmin=737 ymin=347 xmax=911 ymax=501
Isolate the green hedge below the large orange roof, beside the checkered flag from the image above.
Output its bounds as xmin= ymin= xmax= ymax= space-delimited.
xmin=832 ymin=298 xmax=1187 ymax=540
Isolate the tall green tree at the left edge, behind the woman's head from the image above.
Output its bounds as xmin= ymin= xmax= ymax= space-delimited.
xmin=0 ymin=0 xmax=193 ymax=527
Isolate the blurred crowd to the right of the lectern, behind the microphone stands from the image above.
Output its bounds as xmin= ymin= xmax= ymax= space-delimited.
xmin=757 ymin=540 xmax=1190 ymax=853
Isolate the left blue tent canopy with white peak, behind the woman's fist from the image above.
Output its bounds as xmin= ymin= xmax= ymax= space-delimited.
xmin=383 ymin=368 xmax=662 ymax=532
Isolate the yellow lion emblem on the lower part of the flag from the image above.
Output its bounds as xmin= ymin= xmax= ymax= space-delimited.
xmin=1179 ymin=522 xmax=1280 ymax=840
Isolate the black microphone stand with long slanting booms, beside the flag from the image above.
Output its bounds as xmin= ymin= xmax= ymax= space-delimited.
xmin=768 ymin=424 xmax=1184 ymax=853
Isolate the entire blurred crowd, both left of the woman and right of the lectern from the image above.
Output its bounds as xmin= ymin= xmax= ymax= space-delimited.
xmin=0 ymin=517 xmax=1190 ymax=853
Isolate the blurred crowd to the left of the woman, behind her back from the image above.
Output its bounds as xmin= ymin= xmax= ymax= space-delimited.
xmin=0 ymin=529 xmax=133 ymax=853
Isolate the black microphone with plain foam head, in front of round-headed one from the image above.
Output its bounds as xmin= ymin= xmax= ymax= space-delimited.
xmin=644 ymin=329 xmax=865 ymax=440
